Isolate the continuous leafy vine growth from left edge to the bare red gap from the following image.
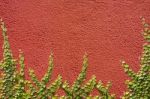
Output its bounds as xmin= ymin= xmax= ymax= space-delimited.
xmin=0 ymin=20 xmax=114 ymax=99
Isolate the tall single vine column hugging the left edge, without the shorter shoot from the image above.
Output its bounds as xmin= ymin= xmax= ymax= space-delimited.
xmin=1 ymin=19 xmax=16 ymax=99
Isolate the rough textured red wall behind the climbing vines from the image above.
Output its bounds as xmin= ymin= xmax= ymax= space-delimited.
xmin=0 ymin=0 xmax=150 ymax=97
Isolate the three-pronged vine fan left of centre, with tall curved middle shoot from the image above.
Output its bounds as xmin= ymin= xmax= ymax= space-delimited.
xmin=29 ymin=54 xmax=62 ymax=99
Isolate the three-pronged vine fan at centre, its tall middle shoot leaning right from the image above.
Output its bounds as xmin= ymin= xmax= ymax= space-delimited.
xmin=62 ymin=54 xmax=96 ymax=99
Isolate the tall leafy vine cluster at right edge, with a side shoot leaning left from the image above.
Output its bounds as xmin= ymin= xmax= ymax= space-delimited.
xmin=122 ymin=18 xmax=150 ymax=99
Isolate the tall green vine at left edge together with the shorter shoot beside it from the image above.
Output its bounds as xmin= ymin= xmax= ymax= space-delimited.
xmin=0 ymin=19 xmax=26 ymax=99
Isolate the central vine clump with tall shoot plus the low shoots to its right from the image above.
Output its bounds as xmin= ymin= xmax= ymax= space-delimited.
xmin=62 ymin=54 xmax=114 ymax=99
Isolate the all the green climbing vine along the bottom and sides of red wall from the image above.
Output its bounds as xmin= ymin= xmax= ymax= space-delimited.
xmin=0 ymin=18 xmax=150 ymax=99
